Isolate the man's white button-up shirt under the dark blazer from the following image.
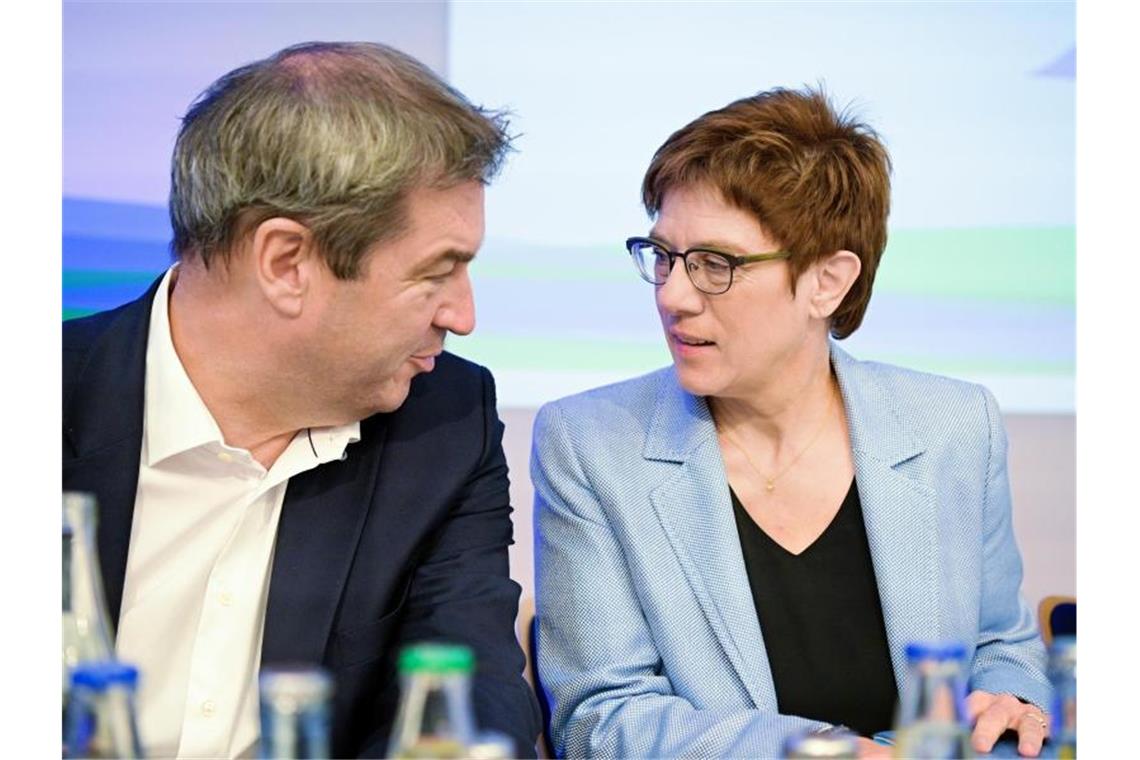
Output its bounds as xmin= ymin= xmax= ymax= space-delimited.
xmin=115 ymin=265 xmax=360 ymax=758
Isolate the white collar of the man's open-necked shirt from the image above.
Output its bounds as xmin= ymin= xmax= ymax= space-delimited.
xmin=143 ymin=264 xmax=360 ymax=467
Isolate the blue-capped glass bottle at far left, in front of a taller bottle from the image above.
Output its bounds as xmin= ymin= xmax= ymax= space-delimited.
xmin=66 ymin=661 xmax=144 ymax=759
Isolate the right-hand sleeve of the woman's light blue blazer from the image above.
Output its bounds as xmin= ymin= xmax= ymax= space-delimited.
xmin=970 ymin=389 xmax=1052 ymax=711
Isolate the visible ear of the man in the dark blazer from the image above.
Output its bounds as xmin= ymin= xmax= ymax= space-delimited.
xmin=251 ymin=216 xmax=318 ymax=318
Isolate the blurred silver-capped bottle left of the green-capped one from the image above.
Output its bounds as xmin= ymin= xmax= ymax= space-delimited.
xmin=259 ymin=665 xmax=333 ymax=760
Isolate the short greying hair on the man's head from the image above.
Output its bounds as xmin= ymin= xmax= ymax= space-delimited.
xmin=170 ymin=42 xmax=511 ymax=279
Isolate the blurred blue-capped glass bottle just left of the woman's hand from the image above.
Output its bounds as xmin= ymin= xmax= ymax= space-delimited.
xmin=895 ymin=641 xmax=972 ymax=760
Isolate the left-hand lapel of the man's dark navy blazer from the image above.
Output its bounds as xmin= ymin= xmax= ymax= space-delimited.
xmin=63 ymin=277 xmax=162 ymax=627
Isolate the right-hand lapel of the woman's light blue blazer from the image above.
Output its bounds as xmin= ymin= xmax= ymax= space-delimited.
xmin=831 ymin=344 xmax=942 ymax=684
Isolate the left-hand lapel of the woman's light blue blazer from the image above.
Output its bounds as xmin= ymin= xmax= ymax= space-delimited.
xmin=644 ymin=371 xmax=776 ymax=710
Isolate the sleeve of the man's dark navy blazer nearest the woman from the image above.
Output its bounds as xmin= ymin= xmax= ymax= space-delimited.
xmin=371 ymin=368 xmax=542 ymax=758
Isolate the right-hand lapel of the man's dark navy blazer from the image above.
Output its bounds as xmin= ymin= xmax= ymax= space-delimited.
xmin=261 ymin=415 xmax=386 ymax=663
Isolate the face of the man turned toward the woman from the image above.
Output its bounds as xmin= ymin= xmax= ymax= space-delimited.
xmin=304 ymin=182 xmax=483 ymax=424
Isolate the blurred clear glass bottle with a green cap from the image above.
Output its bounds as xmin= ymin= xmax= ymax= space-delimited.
xmin=388 ymin=644 xmax=475 ymax=758
